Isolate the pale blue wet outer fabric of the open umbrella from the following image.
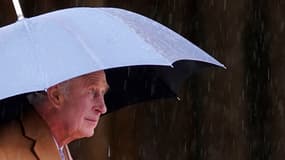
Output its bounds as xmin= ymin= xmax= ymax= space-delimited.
xmin=0 ymin=8 xmax=224 ymax=112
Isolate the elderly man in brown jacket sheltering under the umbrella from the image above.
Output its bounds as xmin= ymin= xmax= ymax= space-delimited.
xmin=0 ymin=71 xmax=108 ymax=160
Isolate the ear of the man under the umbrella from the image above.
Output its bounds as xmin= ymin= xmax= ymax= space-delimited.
xmin=47 ymin=85 xmax=64 ymax=108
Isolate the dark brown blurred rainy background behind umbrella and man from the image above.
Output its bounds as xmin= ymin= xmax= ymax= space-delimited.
xmin=0 ymin=0 xmax=285 ymax=160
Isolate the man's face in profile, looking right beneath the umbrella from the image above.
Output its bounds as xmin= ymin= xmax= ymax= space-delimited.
xmin=56 ymin=71 xmax=108 ymax=138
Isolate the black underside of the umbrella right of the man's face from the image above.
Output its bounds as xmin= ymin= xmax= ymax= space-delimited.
xmin=105 ymin=61 xmax=211 ymax=113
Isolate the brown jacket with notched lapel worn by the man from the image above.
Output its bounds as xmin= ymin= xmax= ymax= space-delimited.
xmin=0 ymin=109 xmax=71 ymax=160
